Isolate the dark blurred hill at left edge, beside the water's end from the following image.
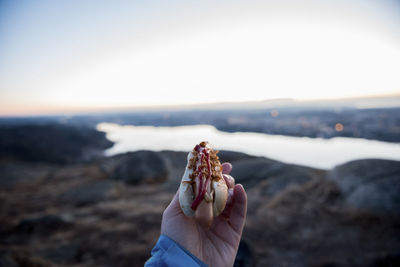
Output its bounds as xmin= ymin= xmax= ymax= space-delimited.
xmin=0 ymin=123 xmax=113 ymax=163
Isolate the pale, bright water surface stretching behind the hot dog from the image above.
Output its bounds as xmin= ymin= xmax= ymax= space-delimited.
xmin=97 ymin=123 xmax=400 ymax=169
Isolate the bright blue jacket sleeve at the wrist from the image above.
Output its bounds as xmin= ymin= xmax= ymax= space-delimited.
xmin=145 ymin=235 xmax=207 ymax=267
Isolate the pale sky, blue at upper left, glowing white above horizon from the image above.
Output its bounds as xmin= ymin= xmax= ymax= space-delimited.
xmin=0 ymin=0 xmax=400 ymax=116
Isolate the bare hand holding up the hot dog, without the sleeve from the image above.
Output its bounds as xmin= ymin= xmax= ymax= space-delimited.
xmin=161 ymin=163 xmax=247 ymax=267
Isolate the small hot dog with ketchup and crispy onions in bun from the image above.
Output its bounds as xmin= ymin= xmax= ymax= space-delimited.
xmin=179 ymin=142 xmax=228 ymax=227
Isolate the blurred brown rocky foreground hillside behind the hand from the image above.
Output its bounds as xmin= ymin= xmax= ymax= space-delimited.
xmin=0 ymin=124 xmax=400 ymax=267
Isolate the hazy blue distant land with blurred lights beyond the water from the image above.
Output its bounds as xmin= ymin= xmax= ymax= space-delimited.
xmin=0 ymin=98 xmax=400 ymax=142
